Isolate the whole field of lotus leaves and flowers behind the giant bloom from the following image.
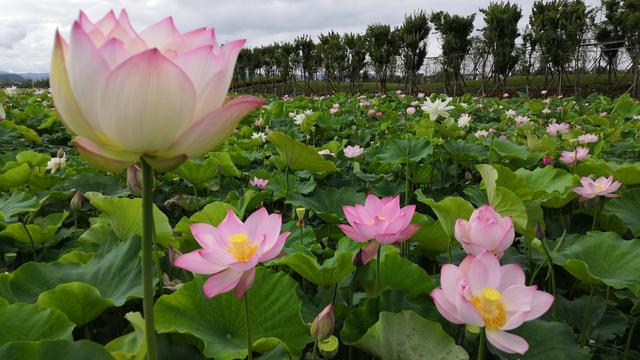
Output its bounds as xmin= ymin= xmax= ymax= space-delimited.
xmin=0 ymin=90 xmax=640 ymax=359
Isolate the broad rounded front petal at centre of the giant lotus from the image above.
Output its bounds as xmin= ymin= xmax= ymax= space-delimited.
xmin=98 ymin=49 xmax=196 ymax=152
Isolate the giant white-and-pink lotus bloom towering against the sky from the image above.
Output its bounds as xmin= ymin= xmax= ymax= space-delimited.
xmin=50 ymin=10 xmax=264 ymax=171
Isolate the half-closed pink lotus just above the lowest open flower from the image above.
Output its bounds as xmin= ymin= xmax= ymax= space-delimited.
xmin=454 ymin=205 xmax=516 ymax=258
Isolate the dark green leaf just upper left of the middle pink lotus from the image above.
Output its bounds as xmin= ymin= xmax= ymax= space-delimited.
xmin=288 ymin=187 xmax=365 ymax=224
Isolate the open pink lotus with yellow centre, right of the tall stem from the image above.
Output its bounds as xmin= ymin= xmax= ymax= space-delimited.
xmin=173 ymin=208 xmax=290 ymax=297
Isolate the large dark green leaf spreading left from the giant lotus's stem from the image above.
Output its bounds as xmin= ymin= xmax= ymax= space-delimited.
xmin=0 ymin=236 xmax=142 ymax=306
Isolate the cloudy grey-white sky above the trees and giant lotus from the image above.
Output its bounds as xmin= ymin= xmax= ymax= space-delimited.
xmin=0 ymin=0 xmax=600 ymax=72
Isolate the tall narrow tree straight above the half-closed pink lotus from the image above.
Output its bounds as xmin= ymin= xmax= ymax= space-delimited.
xmin=480 ymin=2 xmax=522 ymax=88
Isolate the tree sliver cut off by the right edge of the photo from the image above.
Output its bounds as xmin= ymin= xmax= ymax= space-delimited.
xmin=622 ymin=0 xmax=640 ymax=97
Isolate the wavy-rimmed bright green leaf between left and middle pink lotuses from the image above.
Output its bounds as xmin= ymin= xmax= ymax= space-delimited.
xmin=274 ymin=238 xmax=355 ymax=288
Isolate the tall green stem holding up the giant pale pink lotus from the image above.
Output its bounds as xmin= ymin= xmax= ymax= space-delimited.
xmin=141 ymin=160 xmax=158 ymax=360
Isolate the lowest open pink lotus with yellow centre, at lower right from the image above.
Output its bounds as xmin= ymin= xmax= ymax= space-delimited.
xmin=431 ymin=253 xmax=553 ymax=354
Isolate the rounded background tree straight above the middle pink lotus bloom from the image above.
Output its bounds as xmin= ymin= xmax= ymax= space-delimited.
xmin=365 ymin=24 xmax=398 ymax=92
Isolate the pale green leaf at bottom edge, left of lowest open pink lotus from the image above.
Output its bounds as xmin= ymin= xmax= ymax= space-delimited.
xmin=353 ymin=311 xmax=469 ymax=360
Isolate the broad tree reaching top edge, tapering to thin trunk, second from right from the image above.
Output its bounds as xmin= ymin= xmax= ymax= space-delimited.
xmin=529 ymin=0 xmax=588 ymax=93
